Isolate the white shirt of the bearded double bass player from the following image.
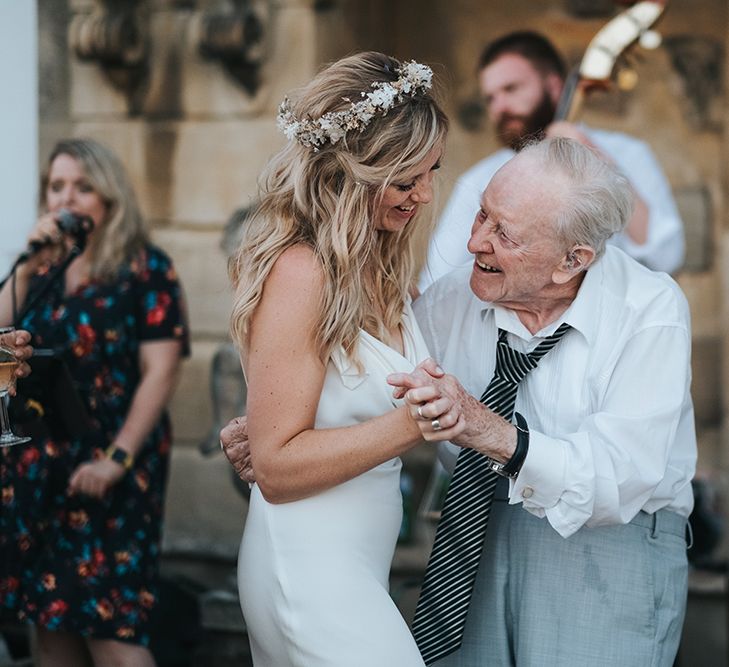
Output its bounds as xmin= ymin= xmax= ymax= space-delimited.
xmin=419 ymin=126 xmax=684 ymax=292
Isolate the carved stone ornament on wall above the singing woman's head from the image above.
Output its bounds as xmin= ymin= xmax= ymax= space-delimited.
xmin=69 ymin=0 xmax=149 ymax=110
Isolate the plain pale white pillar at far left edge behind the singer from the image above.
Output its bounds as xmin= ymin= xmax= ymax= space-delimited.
xmin=0 ymin=0 xmax=38 ymax=276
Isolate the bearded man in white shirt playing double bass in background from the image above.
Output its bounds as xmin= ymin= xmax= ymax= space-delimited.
xmin=420 ymin=31 xmax=684 ymax=290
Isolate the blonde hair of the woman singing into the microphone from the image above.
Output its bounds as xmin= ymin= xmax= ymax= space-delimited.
xmin=40 ymin=139 xmax=149 ymax=282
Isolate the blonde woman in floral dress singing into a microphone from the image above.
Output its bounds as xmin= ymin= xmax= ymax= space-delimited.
xmin=0 ymin=139 xmax=188 ymax=667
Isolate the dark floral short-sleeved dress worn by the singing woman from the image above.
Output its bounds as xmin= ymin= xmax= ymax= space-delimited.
xmin=0 ymin=245 xmax=188 ymax=645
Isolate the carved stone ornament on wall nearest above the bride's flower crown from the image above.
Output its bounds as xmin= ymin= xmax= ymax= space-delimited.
xmin=198 ymin=0 xmax=269 ymax=95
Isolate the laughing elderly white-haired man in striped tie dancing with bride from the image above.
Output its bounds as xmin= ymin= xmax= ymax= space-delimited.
xmin=389 ymin=139 xmax=696 ymax=667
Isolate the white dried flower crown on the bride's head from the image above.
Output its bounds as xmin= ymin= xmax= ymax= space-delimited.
xmin=277 ymin=60 xmax=433 ymax=151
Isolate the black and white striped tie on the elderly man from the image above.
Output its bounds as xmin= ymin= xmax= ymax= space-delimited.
xmin=413 ymin=323 xmax=570 ymax=665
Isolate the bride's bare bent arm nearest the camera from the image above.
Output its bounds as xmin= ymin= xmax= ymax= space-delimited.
xmin=245 ymin=246 xmax=421 ymax=503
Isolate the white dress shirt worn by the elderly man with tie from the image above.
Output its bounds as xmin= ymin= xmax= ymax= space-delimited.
xmin=415 ymin=246 xmax=696 ymax=537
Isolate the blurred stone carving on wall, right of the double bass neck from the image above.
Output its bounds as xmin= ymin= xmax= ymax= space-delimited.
xmin=663 ymin=35 xmax=724 ymax=132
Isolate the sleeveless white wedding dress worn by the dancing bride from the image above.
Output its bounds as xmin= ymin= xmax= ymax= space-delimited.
xmin=238 ymin=306 xmax=428 ymax=667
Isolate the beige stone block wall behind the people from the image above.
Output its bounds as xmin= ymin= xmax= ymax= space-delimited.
xmin=39 ymin=0 xmax=729 ymax=555
